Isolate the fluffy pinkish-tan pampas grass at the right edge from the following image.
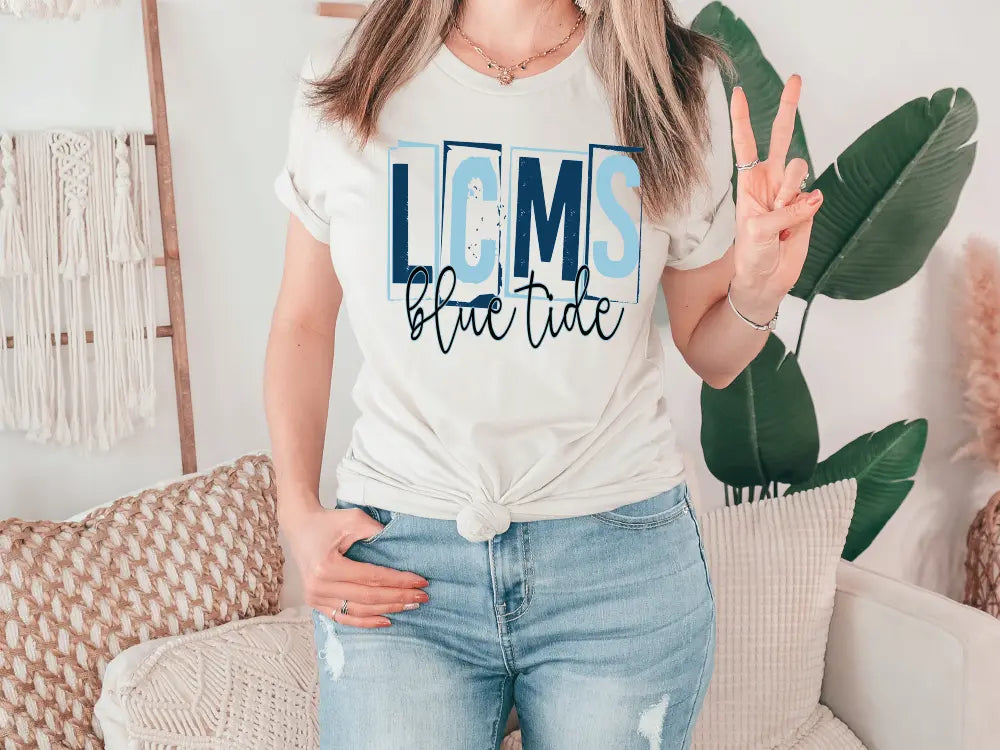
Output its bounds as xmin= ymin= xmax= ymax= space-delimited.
xmin=958 ymin=237 xmax=1000 ymax=472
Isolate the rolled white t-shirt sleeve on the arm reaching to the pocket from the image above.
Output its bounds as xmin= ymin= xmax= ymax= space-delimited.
xmin=274 ymin=57 xmax=330 ymax=244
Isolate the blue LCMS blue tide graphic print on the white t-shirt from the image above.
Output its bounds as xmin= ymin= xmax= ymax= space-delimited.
xmin=387 ymin=141 xmax=642 ymax=353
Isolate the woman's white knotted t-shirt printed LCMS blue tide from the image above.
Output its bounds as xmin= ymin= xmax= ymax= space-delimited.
xmin=275 ymin=38 xmax=735 ymax=541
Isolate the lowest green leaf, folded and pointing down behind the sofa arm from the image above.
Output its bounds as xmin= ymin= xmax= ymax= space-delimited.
xmin=785 ymin=419 xmax=927 ymax=560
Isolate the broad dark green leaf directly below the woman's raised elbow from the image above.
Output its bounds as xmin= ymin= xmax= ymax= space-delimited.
xmin=701 ymin=334 xmax=819 ymax=487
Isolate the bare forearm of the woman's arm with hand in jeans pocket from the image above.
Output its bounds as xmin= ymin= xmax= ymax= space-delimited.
xmin=264 ymin=317 xmax=334 ymax=515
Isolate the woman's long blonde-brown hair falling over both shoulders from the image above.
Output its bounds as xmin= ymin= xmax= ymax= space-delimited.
xmin=309 ymin=0 xmax=729 ymax=222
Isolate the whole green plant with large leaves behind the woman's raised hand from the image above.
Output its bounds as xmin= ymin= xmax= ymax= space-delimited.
xmin=692 ymin=2 xmax=977 ymax=560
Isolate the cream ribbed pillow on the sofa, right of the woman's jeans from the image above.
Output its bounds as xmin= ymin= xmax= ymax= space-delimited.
xmin=694 ymin=479 xmax=864 ymax=750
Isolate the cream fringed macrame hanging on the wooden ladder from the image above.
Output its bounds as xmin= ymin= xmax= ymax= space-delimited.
xmin=0 ymin=130 xmax=156 ymax=450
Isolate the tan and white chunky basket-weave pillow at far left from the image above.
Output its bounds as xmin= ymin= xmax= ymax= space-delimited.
xmin=0 ymin=455 xmax=283 ymax=750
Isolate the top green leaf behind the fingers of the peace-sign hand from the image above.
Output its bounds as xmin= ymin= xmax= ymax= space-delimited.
xmin=691 ymin=2 xmax=815 ymax=196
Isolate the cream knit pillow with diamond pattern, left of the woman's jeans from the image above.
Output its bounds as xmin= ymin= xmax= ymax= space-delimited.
xmin=95 ymin=606 xmax=319 ymax=750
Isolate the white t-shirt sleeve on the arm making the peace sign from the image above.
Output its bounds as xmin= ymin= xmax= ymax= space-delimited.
xmin=663 ymin=64 xmax=736 ymax=270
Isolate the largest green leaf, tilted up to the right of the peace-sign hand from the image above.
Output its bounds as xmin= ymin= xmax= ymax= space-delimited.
xmin=792 ymin=88 xmax=977 ymax=302
